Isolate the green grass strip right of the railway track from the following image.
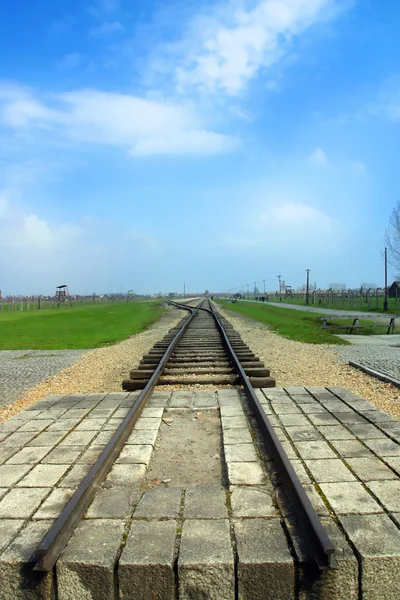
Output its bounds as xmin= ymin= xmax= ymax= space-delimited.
xmin=219 ymin=301 xmax=364 ymax=344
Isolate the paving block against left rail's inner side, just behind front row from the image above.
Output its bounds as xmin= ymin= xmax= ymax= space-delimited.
xmin=86 ymin=487 xmax=139 ymax=519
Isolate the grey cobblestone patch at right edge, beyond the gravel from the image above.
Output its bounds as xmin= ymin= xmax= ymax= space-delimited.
xmin=335 ymin=344 xmax=400 ymax=379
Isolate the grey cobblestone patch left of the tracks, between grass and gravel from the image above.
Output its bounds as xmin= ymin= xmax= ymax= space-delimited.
xmin=0 ymin=350 xmax=87 ymax=406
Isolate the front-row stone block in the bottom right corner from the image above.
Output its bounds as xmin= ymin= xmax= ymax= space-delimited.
xmin=340 ymin=514 xmax=400 ymax=600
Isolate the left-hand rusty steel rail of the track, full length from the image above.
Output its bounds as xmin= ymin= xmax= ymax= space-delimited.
xmin=33 ymin=300 xmax=203 ymax=571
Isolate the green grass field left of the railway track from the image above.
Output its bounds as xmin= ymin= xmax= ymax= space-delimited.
xmin=0 ymin=301 xmax=164 ymax=350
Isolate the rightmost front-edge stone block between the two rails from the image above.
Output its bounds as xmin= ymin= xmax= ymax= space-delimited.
xmin=234 ymin=519 xmax=295 ymax=600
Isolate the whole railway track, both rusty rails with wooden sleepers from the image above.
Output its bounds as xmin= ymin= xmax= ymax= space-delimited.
xmin=34 ymin=301 xmax=334 ymax=571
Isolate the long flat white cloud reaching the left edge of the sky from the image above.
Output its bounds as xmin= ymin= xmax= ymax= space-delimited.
xmin=0 ymin=84 xmax=238 ymax=156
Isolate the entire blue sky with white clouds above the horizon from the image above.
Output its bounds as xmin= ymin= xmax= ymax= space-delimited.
xmin=0 ymin=0 xmax=400 ymax=294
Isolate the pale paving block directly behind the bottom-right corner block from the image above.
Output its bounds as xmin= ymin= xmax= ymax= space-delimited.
xmin=320 ymin=481 xmax=383 ymax=515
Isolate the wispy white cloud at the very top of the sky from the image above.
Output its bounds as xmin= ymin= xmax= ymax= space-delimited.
xmin=175 ymin=0 xmax=343 ymax=95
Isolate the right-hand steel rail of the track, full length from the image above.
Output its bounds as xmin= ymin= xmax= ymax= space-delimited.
xmin=210 ymin=304 xmax=336 ymax=569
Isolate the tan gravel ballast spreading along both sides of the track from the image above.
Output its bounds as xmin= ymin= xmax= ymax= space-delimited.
xmin=0 ymin=307 xmax=400 ymax=421
